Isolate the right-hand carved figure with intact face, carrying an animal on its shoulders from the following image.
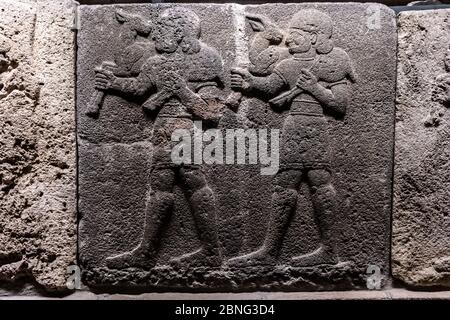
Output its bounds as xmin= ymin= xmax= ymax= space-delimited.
xmin=228 ymin=10 xmax=355 ymax=267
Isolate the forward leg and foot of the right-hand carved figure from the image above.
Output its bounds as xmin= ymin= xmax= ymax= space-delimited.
xmin=228 ymin=170 xmax=302 ymax=266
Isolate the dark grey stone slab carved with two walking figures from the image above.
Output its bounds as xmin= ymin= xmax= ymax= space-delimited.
xmin=77 ymin=3 xmax=397 ymax=291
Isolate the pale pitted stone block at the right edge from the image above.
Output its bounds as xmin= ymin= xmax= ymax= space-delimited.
xmin=392 ymin=9 xmax=450 ymax=286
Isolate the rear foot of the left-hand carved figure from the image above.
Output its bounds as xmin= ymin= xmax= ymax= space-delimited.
xmin=169 ymin=248 xmax=222 ymax=268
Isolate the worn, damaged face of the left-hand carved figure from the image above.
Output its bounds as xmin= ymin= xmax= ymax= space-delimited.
xmin=152 ymin=18 xmax=183 ymax=53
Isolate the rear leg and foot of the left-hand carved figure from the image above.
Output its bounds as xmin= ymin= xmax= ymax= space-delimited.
xmin=171 ymin=168 xmax=222 ymax=267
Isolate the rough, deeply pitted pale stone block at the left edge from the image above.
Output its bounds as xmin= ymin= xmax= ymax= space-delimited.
xmin=0 ymin=1 xmax=77 ymax=290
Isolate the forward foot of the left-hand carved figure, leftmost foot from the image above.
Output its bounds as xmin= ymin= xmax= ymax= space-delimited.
xmin=106 ymin=246 xmax=156 ymax=269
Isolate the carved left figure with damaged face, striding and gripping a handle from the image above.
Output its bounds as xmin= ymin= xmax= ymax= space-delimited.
xmin=92 ymin=8 xmax=229 ymax=269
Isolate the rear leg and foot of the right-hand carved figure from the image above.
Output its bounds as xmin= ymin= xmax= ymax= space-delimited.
xmin=292 ymin=169 xmax=338 ymax=267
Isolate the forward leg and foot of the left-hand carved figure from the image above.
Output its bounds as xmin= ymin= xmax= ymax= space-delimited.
xmin=106 ymin=169 xmax=175 ymax=269
